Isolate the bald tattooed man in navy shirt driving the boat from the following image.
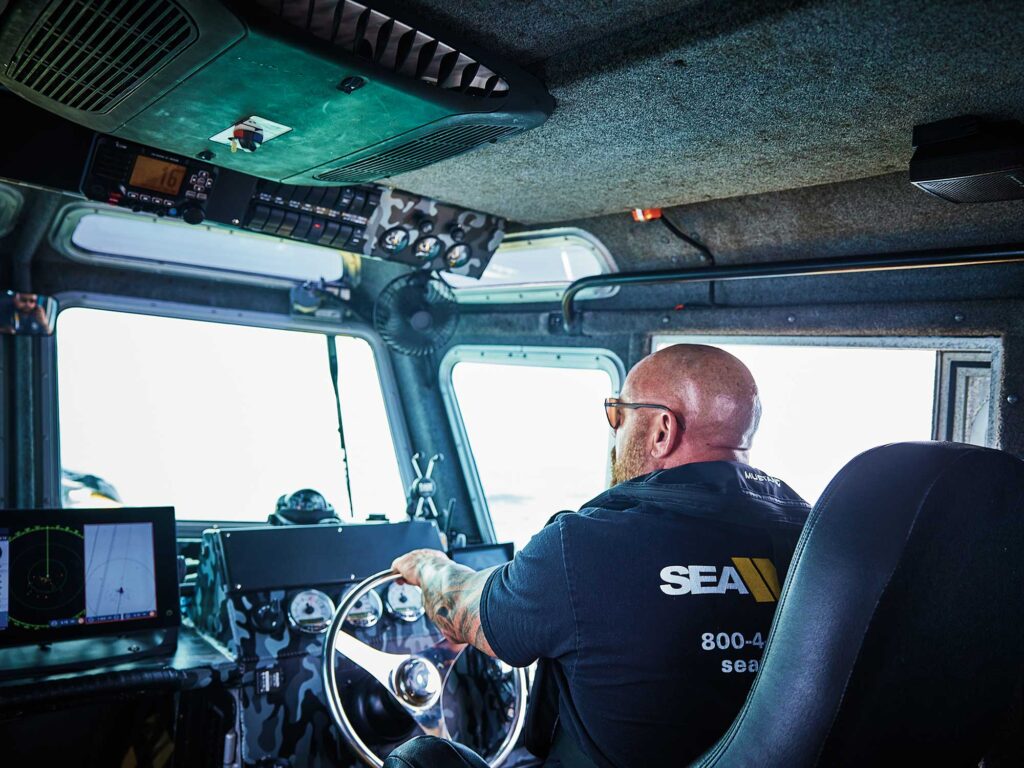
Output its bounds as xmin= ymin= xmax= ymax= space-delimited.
xmin=392 ymin=344 xmax=809 ymax=768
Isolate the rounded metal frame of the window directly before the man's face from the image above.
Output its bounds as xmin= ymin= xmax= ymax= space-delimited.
xmin=437 ymin=344 xmax=626 ymax=544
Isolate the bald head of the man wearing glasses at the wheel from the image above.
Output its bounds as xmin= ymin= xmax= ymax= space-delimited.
xmin=611 ymin=344 xmax=761 ymax=484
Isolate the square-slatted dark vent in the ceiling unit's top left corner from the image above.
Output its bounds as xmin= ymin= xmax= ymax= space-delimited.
xmin=7 ymin=0 xmax=197 ymax=113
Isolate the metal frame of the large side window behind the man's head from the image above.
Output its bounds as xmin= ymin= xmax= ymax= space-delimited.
xmin=649 ymin=333 xmax=1004 ymax=447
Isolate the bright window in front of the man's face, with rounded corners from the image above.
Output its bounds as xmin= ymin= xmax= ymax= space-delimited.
xmin=449 ymin=347 xmax=620 ymax=549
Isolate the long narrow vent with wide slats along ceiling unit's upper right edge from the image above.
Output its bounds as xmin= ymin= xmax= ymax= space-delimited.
xmin=256 ymin=0 xmax=509 ymax=97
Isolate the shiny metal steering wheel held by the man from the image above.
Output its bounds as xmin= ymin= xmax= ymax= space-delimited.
xmin=324 ymin=570 xmax=526 ymax=768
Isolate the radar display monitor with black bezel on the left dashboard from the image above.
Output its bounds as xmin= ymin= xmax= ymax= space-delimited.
xmin=0 ymin=509 xmax=179 ymax=645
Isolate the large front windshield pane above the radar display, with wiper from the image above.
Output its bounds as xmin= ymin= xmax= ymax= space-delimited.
xmin=56 ymin=308 xmax=406 ymax=521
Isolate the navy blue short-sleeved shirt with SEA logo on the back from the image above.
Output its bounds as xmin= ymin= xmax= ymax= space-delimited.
xmin=480 ymin=462 xmax=810 ymax=768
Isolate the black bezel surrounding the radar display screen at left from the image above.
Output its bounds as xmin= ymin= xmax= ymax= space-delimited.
xmin=0 ymin=507 xmax=181 ymax=648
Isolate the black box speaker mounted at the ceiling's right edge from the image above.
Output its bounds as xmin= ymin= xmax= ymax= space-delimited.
xmin=910 ymin=115 xmax=1024 ymax=203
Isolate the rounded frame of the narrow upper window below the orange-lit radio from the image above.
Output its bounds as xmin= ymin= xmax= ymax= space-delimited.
xmin=49 ymin=203 xmax=360 ymax=288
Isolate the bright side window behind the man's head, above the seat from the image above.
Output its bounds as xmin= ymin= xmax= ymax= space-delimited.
xmin=652 ymin=336 xmax=991 ymax=504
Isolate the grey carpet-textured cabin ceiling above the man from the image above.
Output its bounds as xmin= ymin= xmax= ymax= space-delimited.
xmin=391 ymin=0 xmax=1024 ymax=226
